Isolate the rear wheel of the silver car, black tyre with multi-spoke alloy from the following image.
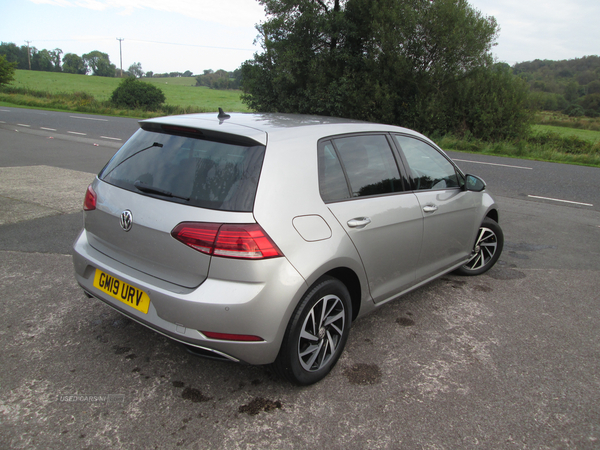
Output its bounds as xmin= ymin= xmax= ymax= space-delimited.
xmin=273 ymin=277 xmax=352 ymax=385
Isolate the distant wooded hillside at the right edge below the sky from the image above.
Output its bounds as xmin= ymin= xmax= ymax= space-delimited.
xmin=513 ymin=56 xmax=600 ymax=117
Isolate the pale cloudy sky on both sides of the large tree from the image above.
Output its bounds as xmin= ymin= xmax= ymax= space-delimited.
xmin=0 ymin=0 xmax=600 ymax=74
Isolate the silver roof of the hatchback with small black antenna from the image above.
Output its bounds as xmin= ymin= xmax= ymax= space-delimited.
xmin=140 ymin=113 xmax=421 ymax=145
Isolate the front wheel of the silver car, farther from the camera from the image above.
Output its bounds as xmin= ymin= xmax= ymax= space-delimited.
xmin=456 ymin=217 xmax=504 ymax=275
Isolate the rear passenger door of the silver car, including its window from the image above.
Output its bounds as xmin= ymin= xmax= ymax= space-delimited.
xmin=319 ymin=134 xmax=423 ymax=302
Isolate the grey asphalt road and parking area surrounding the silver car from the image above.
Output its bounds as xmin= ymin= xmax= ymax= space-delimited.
xmin=0 ymin=108 xmax=600 ymax=449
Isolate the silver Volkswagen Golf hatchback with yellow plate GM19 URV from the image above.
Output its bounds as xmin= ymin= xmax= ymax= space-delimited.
xmin=73 ymin=111 xmax=503 ymax=385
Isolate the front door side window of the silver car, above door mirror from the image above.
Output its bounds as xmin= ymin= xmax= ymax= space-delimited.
xmin=394 ymin=135 xmax=460 ymax=190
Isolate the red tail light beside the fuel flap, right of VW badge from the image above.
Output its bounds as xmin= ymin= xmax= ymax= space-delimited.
xmin=171 ymin=222 xmax=283 ymax=259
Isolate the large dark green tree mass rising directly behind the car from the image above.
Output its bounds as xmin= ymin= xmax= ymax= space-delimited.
xmin=242 ymin=0 xmax=526 ymax=139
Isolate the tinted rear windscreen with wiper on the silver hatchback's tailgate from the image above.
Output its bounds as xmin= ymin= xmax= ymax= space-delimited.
xmin=99 ymin=130 xmax=265 ymax=211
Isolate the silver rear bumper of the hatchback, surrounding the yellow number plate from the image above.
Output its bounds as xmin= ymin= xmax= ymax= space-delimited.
xmin=73 ymin=230 xmax=306 ymax=364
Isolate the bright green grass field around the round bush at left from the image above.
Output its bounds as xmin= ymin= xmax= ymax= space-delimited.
xmin=9 ymin=70 xmax=248 ymax=112
